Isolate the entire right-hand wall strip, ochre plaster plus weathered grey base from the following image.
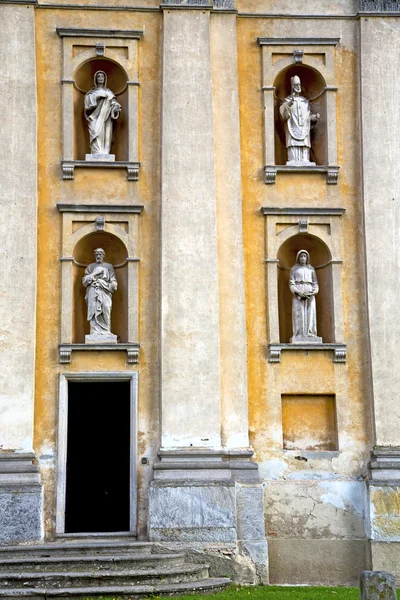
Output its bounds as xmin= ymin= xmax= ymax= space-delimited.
xmin=237 ymin=8 xmax=371 ymax=583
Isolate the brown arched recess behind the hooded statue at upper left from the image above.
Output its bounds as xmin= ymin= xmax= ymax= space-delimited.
xmin=73 ymin=57 xmax=129 ymax=161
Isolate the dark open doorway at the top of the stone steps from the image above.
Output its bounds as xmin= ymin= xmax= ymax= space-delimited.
xmin=65 ymin=381 xmax=131 ymax=533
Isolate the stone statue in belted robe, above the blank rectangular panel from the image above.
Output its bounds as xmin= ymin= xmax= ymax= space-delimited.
xmin=289 ymin=250 xmax=322 ymax=344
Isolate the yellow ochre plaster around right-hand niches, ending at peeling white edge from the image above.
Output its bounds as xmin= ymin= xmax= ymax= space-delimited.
xmin=237 ymin=16 xmax=371 ymax=477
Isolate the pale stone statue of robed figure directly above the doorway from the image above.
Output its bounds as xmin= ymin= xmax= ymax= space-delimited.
xmin=82 ymin=248 xmax=118 ymax=344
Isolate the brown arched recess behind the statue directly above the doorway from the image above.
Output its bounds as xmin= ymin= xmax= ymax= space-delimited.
xmin=72 ymin=231 xmax=128 ymax=344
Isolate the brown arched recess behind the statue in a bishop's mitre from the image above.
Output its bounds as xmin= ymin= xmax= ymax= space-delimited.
xmin=273 ymin=64 xmax=328 ymax=165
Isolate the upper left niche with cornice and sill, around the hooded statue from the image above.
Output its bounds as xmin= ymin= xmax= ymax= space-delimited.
xmin=57 ymin=28 xmax=143 ymax=181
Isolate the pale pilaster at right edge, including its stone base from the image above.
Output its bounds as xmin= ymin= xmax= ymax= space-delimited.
xmin=360 ymin=8 xmax=400 ymax=577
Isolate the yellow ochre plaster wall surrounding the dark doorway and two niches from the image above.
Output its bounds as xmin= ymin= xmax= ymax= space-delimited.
xmin=35 ymin=9 xmax=161 ymax=535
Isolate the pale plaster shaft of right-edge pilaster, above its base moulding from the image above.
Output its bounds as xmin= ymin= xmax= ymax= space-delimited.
xmin=360 ymin=17 xmax=400 ymax=446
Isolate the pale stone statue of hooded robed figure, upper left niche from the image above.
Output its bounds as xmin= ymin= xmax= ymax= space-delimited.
xmin=85 ymin=71 xmax=121 ymax=161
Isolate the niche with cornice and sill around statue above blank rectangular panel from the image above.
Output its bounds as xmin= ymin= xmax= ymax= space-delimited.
xmin=262 ymin=206 xmax=346 ymax=362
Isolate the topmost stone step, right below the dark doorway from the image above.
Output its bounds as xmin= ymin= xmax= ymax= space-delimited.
xmin=0 ymin=539 xmax=154 ymax=560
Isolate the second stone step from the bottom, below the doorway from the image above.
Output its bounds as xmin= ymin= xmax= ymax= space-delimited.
xmin=0 ymin=564 xmax=208 ymax=590
